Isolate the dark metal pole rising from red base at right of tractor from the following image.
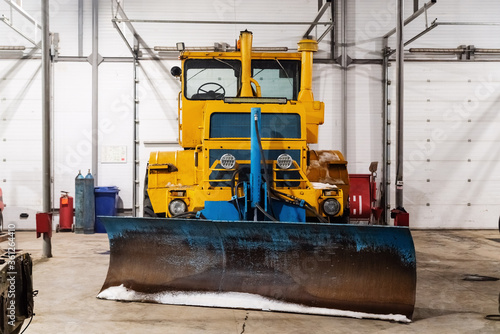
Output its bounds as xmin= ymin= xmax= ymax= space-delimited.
xmin=396 ymin=0 xmax=404 ymax=208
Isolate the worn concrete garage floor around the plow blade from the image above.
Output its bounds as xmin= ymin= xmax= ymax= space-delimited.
xmin=5 ymin=230 xmax=500 ymax=334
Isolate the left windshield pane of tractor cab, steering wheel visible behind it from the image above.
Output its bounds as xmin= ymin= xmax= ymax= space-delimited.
xmin=184 ymin=59 xmax=241 ymax=100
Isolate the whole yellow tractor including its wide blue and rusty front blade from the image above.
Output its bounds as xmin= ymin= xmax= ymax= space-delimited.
xmin=99 ymin=31 xmax=416 ymax=321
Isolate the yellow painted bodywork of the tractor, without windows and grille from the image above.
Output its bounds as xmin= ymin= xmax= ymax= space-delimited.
xmin=147 ymin=31 xmax=349 ymax=217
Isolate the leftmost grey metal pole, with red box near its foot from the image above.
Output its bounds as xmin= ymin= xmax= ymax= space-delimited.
xmin=42 ymin=0 xmax=52 ymax=257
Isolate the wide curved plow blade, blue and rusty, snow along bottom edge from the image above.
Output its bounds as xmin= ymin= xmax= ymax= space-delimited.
xmin=98 ymin=217 xmax=416 ymax=322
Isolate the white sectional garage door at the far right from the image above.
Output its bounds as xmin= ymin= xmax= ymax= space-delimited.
xmin=390 ymin=62 xmax=500 ymax=228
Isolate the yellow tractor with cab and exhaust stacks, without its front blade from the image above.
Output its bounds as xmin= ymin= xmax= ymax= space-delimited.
xmin=144 ymin=32 xmax=349 ymax=222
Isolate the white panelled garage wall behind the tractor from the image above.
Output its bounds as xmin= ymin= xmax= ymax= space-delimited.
xmin=0 ymin=0 xmax=500 ymax=228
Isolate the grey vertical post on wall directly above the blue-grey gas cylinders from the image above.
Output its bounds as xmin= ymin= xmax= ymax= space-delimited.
xmin=91 ymin=0 xmax=99 ymax=186
